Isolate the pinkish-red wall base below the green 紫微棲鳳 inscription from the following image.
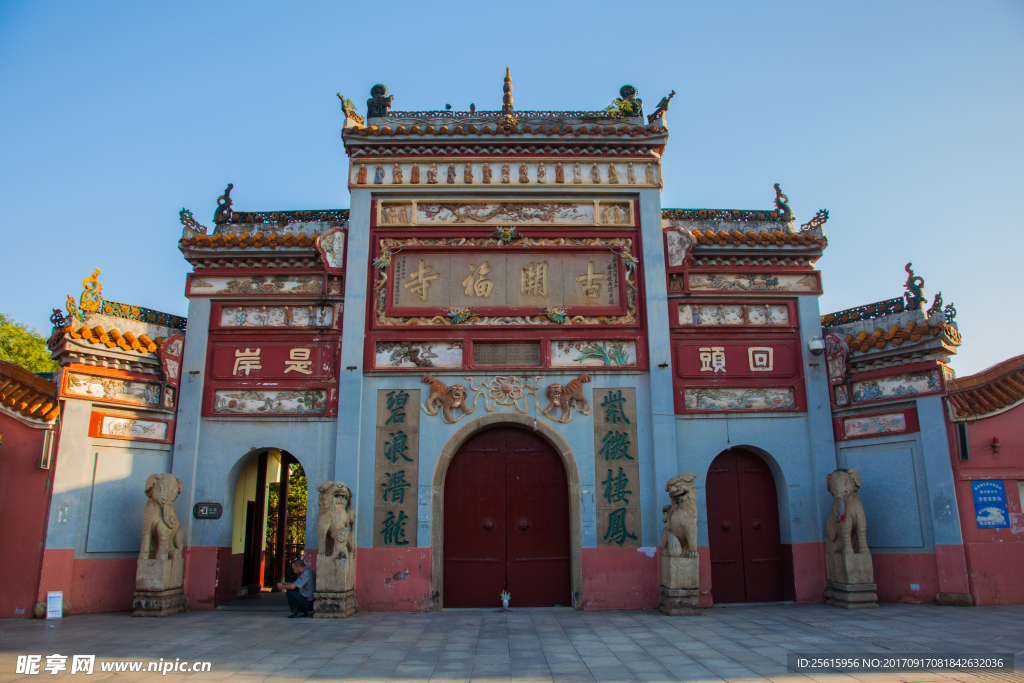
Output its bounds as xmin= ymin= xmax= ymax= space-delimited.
xmin=583 ymin=548 xmax=662 ymax=609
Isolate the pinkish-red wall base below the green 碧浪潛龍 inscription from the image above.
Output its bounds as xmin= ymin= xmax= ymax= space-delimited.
xmin=358 ymin=548 xmax=430 ymax=611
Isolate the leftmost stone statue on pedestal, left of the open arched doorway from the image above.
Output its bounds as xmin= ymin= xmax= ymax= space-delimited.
xmin=132 ymin=473 xmax=188 ymax=616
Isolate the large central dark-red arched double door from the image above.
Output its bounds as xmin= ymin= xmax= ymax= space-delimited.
xmin=444 ymin=427 xmax=572 ymax=607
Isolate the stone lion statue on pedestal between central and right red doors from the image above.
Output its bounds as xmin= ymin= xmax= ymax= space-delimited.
xmin=657 ymin=472 xmax=700 ymax=616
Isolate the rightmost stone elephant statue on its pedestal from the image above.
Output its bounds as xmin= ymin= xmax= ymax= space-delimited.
xmin=825 ymin=468 xmax=879 ymax=609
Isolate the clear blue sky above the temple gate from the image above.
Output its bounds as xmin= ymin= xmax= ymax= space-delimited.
xmin=0 ymin=0 xmax=1024 ymax=376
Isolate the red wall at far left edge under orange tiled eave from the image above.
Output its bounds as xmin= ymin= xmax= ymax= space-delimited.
xmin=0 ymin=415 xmax=50 ymax=618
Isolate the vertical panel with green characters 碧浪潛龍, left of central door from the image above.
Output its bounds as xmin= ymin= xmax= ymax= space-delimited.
xmin=373 ymin=389 xmax=420 ymax=548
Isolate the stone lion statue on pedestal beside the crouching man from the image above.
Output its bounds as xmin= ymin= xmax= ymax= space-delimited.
xmin=313 ymin=481 xmax=357 ymax=618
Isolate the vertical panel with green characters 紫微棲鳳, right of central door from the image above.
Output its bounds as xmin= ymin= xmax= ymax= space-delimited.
xmin=593 ymin=388 xmax=641 ymax=548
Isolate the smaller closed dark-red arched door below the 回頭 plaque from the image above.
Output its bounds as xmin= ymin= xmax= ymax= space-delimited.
xmin=705 ymin=449 xmax=782 ymax=602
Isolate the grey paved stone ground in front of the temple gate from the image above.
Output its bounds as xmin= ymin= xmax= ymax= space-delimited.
xmin=0 ymin=604 xmax=1024 ymax=683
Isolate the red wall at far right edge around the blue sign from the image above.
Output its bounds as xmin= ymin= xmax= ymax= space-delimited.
xmin=943 ymin=405 xmax=1024 ymax=605
